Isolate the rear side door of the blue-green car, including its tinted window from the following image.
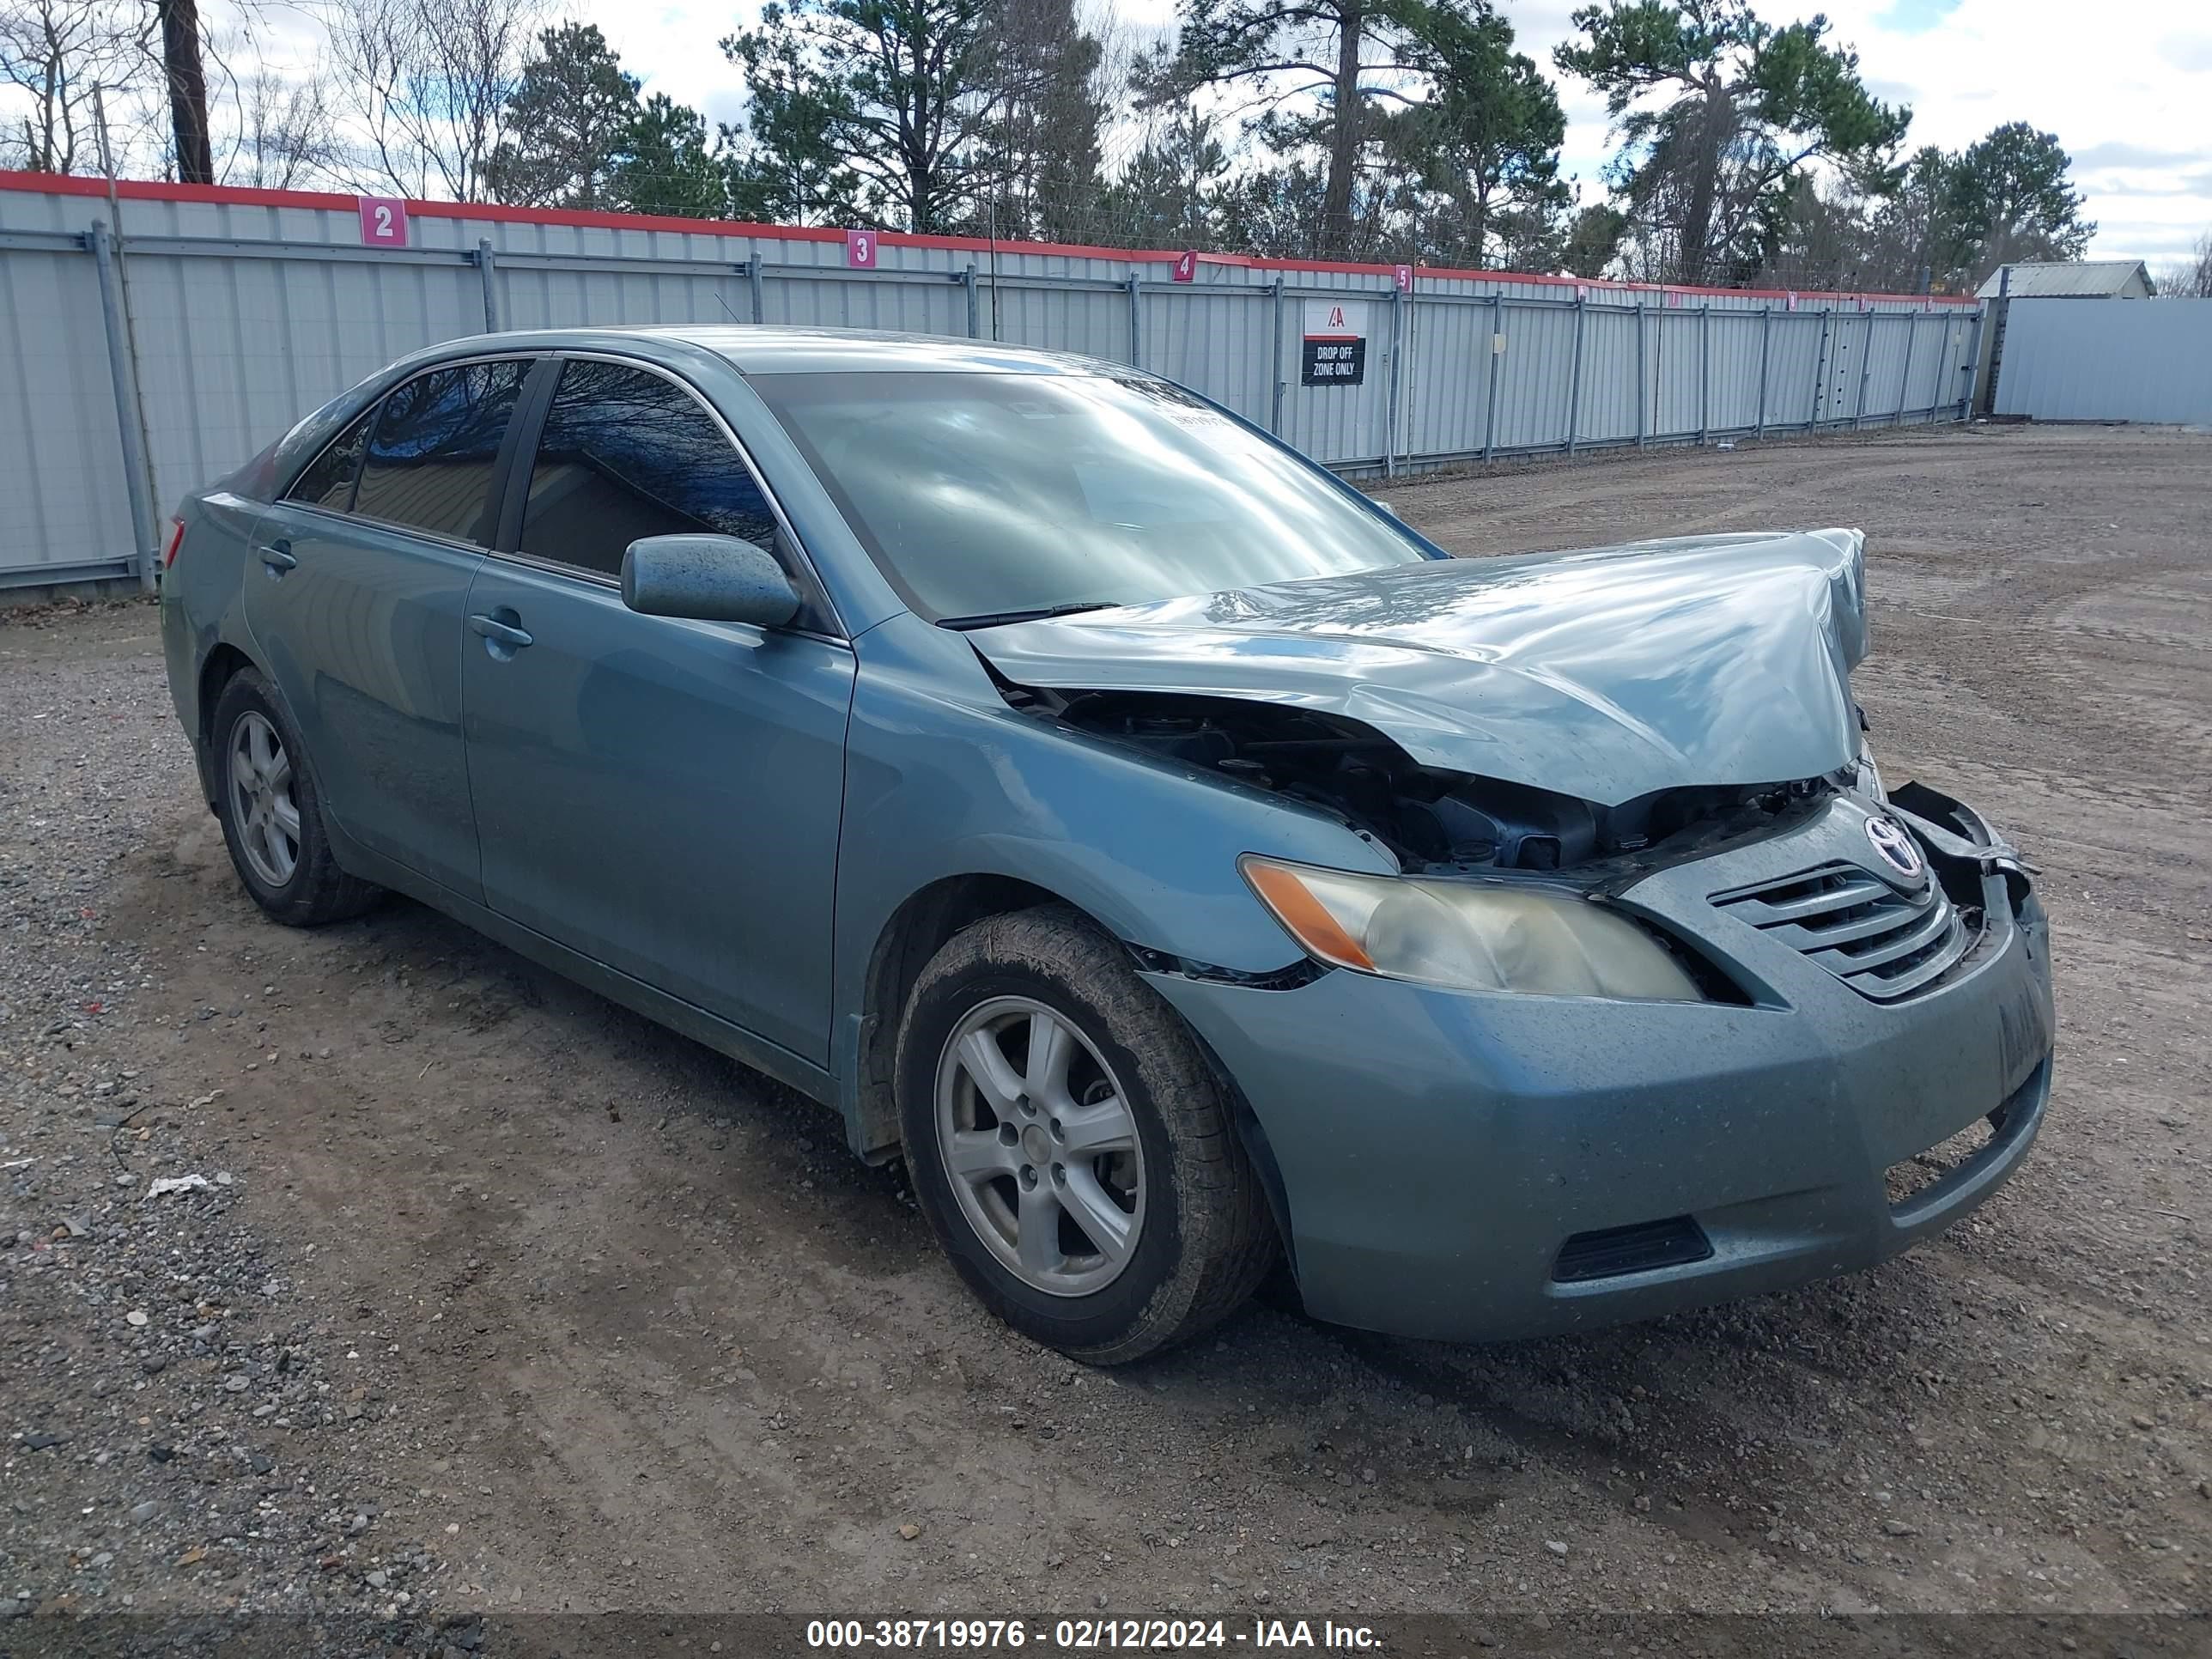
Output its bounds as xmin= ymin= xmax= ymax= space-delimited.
xmin=246 ymin=358 xmax=533 ymax=900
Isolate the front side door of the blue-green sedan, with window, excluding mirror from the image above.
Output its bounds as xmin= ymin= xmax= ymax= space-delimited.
xmin=462 ymin=356 xmax=854 ymax=1066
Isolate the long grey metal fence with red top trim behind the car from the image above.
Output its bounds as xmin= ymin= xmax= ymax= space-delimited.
xmin=0 ymin=175 xmax=1980 ymax=586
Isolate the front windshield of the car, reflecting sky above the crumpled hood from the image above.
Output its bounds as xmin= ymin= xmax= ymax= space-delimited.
xmin=752 ymin=374 xmax=1437 ymax=622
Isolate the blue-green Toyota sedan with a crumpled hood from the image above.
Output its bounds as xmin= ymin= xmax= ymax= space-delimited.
xmin=161 ymin=327 xmax=2053 ymax=1363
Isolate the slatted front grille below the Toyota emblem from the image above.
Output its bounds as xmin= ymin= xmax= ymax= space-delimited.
xmin=1712 ymin=863 xmax=1973 ymax=1002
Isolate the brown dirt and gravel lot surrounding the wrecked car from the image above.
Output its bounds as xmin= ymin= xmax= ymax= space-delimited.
xmin=0 ymin=429 xmax=2212 ymax=1646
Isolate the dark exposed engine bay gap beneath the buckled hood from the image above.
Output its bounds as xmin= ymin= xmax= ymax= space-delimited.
xmin=998 ymin=679 xmax=1856 ymax=878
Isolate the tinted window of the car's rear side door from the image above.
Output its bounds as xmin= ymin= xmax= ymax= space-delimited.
xmin=354 ymin=362 xmax=531 ymax=546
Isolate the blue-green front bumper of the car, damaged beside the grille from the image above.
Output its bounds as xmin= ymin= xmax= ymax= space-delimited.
xmin=1148 ymin=787 xmax=2053 ymax=1340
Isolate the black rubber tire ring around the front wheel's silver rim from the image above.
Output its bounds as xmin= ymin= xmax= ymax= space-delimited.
xmin=898 ymin=963 xmax=1183 ymax=1352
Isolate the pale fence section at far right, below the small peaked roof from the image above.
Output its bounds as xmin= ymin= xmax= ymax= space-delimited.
xmin=1993 ymin=299 xmax=2212 ymax=425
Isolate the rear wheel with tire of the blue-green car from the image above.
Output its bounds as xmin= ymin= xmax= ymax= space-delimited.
xmin=212 ymin=668 xmax=383 ymax=927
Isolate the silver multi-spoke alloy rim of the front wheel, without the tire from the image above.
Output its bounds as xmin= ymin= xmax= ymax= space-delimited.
xmin=936 ymin=998 xmax=1144 ymax=1297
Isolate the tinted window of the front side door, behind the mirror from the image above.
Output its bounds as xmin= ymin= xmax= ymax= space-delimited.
xmin=522 ymin=362 xmax=776 ymax=575
